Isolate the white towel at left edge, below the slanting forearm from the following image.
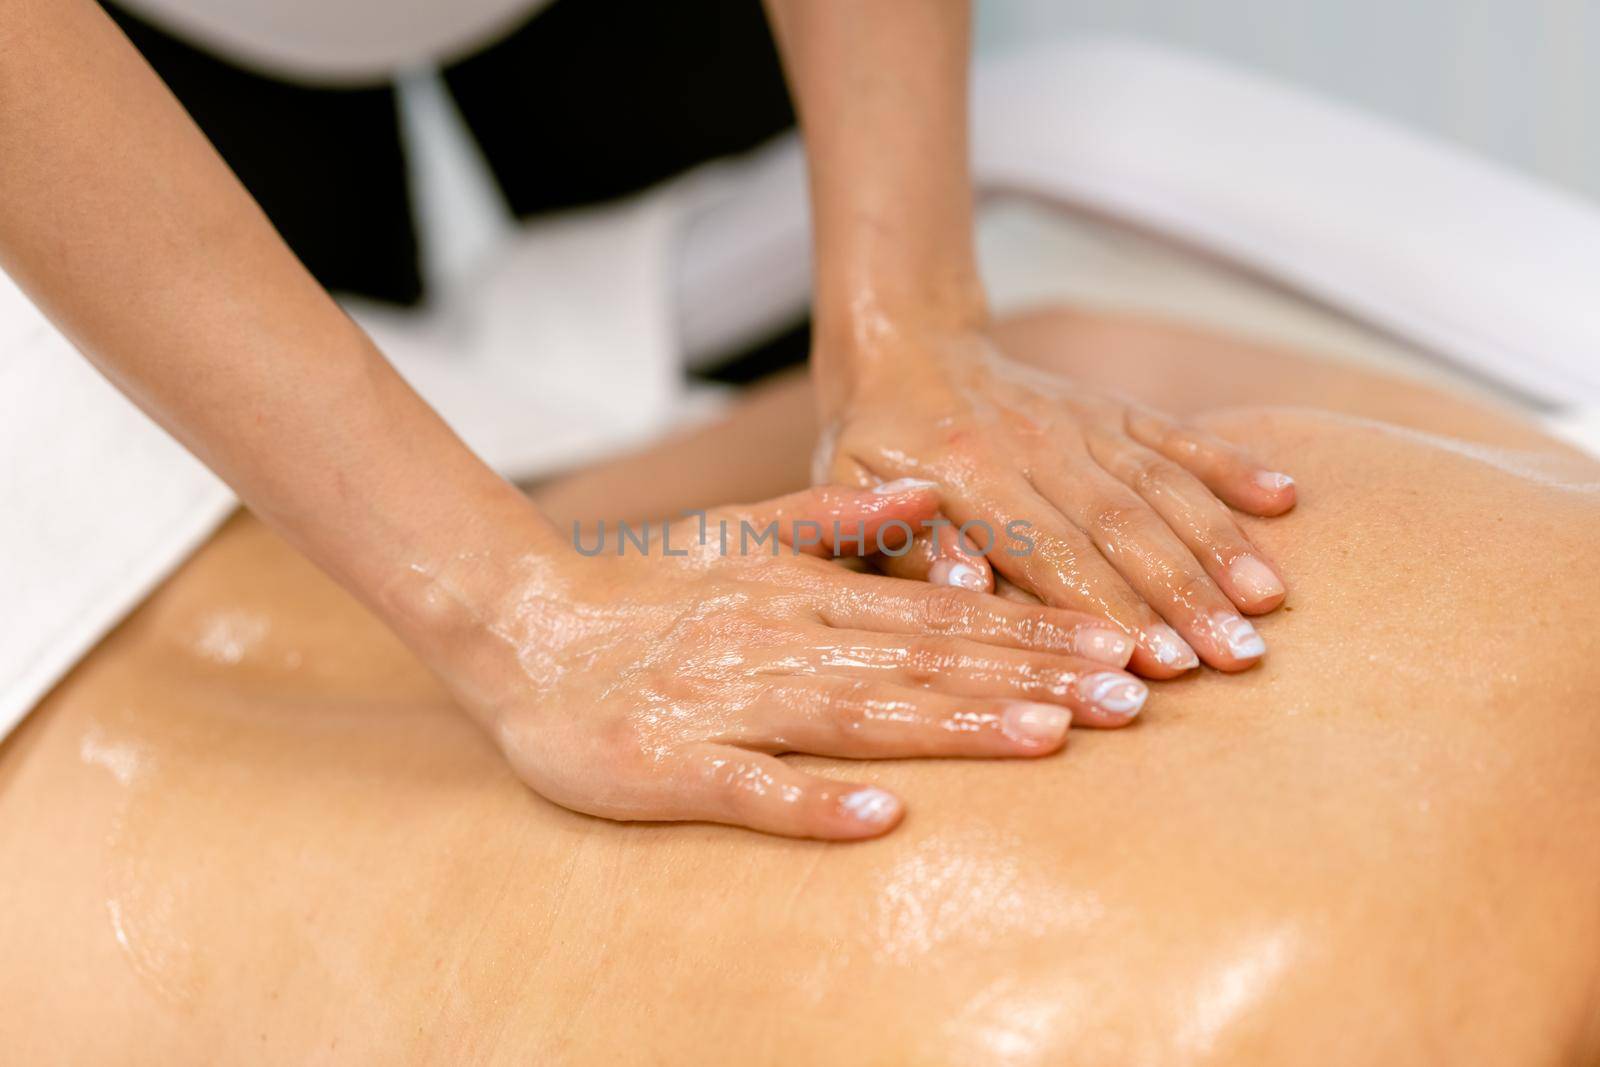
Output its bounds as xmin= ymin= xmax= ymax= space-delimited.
xmin=0 ymin=274 xmax=234 ymax=736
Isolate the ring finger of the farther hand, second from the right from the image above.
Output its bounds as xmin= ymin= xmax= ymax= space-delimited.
xmin=1090 ymin=434 xmax=1285 ymax=614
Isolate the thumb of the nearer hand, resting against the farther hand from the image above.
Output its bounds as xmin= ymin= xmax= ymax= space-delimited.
xmin=730 ymin=478 xmax=939 ymax=557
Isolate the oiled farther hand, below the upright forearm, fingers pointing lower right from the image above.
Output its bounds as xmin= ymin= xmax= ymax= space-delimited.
xmin=818 ymin=330 xmax=1294 ymax=677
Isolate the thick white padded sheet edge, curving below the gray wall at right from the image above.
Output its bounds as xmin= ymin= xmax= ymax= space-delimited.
xmin=974 ymin=42 xmax=1600 ymax=408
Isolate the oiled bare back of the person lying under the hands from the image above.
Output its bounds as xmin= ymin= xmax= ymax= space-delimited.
xmin=0 ymin=308 xmax=1600 ymax=1067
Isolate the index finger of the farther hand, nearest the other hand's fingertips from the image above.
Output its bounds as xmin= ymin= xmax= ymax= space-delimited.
xmin=946 ymin=477 xmax=1200 ymax=678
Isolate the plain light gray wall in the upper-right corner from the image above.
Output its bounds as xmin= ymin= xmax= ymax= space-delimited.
xmin=978 ymin=0 xmax=1600 ymax=202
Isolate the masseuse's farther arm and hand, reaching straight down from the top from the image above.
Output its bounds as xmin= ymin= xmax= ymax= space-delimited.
xmin=768 ymin=0 xmax=1294 ymax=678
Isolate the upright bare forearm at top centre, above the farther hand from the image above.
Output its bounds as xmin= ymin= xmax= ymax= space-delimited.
xmin=768 ymin=0 xmax=987 ymax=404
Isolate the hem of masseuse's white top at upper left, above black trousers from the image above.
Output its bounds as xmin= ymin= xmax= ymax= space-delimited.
xmin=117 ymin=0 xmax=550 ymax=85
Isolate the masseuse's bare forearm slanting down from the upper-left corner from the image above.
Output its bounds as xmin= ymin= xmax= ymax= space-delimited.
xmin=0 ymin=0 xmax=557 ymax=668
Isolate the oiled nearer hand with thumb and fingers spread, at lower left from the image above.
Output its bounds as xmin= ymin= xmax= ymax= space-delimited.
xmin=458 ymin=486 xmax=1146 ymax=838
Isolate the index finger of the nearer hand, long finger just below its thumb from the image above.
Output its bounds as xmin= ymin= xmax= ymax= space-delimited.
xmin=813 ymin=574 xmax=1134 ymax=667
